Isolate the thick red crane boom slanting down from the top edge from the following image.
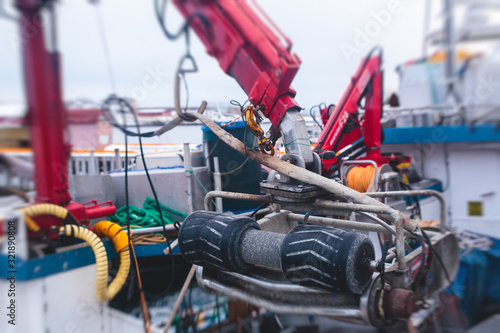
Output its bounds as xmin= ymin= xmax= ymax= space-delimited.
xmin=174 ymin=0 xmax=300 ymax=127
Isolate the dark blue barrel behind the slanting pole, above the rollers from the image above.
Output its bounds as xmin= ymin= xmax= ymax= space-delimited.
xmin=201 ymin=121 xmax=262 ymax=212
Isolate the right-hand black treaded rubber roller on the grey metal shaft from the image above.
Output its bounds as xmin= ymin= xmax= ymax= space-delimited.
xmin=280 ymin=225 xmax=375 ymax=294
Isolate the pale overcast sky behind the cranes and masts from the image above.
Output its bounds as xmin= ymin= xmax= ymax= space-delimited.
xmin=0 ymin=0 xmax=438 ymax=113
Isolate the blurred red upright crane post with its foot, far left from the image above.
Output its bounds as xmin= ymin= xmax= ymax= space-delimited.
xmin=17 ymin=0 xmax=116 ymax=229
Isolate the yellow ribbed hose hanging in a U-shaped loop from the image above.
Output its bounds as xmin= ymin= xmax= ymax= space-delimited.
xmin=60 ymin=221 xmax=130 ymax=302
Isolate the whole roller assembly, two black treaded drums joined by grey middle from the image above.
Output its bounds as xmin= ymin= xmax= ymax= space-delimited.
xmin=179 ymin=211 xmax=375 ymax=294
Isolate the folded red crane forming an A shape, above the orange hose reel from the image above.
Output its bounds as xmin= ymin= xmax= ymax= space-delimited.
xmin=314 ymin=56 xmax=387 ymax=171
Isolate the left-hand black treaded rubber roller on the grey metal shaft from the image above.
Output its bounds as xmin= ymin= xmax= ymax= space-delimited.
xmin=178 ymin=211 xmax=260 ymax=272
